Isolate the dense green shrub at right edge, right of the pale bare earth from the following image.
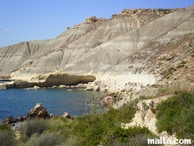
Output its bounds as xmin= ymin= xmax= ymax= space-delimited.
xmin=156 ymin=91 xmax=194 ymax=139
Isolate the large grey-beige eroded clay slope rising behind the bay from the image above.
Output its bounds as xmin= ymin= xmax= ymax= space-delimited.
xmin=0 ymin=6 xmax=194 ymax=90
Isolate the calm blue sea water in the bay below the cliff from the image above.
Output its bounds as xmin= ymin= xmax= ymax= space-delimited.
xmin=0 ymin=88 xmax=102 ymax=120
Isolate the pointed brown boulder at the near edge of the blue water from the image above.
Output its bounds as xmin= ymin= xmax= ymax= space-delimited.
xmin=27 ymin=103 xmax=49 ymax=119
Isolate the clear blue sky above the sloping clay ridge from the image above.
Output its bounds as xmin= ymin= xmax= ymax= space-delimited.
xmin=0 ymin=0 xmax=194 ymax=47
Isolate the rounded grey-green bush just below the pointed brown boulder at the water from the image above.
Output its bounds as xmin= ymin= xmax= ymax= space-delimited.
xmin=21 ymin=119 xmax=49 ymax=139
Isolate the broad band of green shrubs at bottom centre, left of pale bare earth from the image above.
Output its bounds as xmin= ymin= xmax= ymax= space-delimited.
xmin=38 ymin=100 xmax=156 ymax=146
